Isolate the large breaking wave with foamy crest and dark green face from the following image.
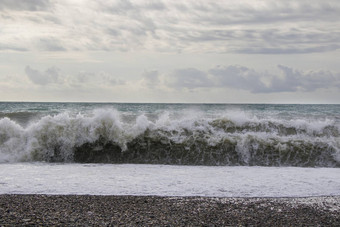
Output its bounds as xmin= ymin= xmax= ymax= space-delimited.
xmin=0 ymin=109 xmax=340 ymax=167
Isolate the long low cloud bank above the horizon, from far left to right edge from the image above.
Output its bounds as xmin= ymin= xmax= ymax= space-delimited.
xmin=25 ymin=65 xmax=340 ymax=94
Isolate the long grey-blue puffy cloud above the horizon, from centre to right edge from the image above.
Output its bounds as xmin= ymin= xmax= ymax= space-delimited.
xmin=148 ymin=65 xmax=340 ymax=94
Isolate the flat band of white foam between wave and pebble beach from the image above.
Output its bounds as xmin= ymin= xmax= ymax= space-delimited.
xmin=0 ymin=163 xmax=340 ymax=197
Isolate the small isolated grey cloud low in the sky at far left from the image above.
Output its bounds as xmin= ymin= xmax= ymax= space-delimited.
xmin=25 ymin=66 xmax=60 ymax=85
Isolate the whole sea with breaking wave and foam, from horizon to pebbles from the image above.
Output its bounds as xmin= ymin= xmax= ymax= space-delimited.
xmin=0 ymin=102 xmax=340 ymax=197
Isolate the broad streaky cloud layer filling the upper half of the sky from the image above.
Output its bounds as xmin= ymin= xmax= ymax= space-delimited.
xmin=0 ymin=0 xmax=340 ymax=54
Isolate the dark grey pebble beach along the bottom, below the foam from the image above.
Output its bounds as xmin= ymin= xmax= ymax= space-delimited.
xmin=0 ymin=194 xmax=340 ymax=226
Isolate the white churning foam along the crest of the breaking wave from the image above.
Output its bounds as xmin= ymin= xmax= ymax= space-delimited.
xmin=0 ymin=106 xmax=340 ymax=166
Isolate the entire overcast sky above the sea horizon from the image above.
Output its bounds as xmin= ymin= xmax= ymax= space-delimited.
xmin=0 ymin=0 xmax=340 ymax=104
